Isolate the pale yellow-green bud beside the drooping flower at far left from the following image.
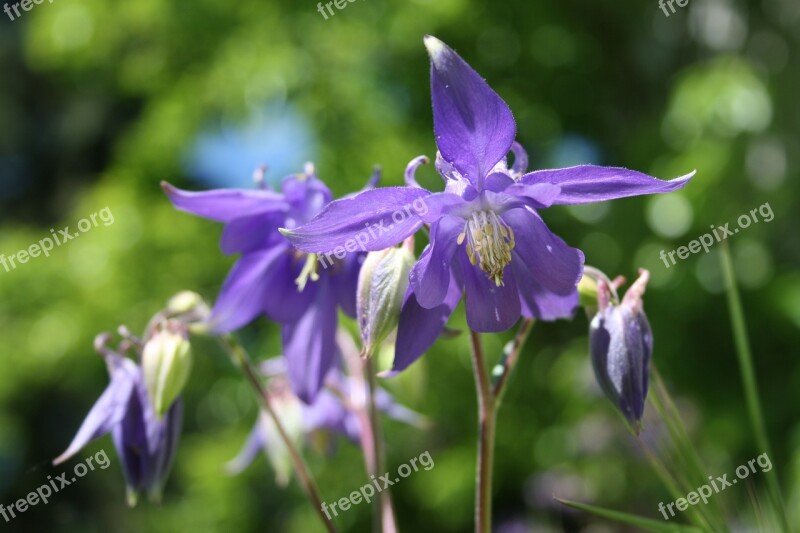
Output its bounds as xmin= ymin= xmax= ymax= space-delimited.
xmin=142 ymin=320 xmax=192 ymax=418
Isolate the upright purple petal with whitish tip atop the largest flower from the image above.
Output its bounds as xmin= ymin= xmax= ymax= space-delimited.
xmin=425 ymin=35 xmax=516 ymax=190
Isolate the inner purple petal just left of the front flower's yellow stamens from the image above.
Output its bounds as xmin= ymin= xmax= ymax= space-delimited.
xmin=409 ymin=215 xmax=464 ymax=309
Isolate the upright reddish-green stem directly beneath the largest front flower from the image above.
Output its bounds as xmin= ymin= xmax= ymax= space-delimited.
xmin=470 ymin=330 xmax=497 ymax=533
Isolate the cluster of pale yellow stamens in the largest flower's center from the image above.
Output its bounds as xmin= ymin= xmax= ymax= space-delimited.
xmin=457 ymin=211 xmax=514 ymax=287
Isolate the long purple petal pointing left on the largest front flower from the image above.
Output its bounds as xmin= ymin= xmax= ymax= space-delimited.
xmin=281 ymin=187 xmax=431 ymax=254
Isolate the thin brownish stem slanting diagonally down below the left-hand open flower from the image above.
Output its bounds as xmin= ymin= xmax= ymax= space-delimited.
xmin=219 ymin=335 xmax=336 ymax=533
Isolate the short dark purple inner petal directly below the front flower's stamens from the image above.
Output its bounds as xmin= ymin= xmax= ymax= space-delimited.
xmin=457 ymin=251 xmax=521 ymax=333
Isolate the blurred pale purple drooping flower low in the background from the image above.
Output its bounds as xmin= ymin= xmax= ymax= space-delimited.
xmin=227 ymin=358 xmax=423 ymax=480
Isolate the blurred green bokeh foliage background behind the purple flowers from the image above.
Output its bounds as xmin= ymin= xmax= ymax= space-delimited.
xmin=0 ymin=0 xmax=800 ymax=533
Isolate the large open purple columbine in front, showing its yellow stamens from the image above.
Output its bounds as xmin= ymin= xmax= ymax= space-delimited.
xmin=283 ymin=36 xmax=693 ymax=370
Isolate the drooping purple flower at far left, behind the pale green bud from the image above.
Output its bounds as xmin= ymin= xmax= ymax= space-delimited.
xmin=53 ymin=334 xmax=183 ymax=505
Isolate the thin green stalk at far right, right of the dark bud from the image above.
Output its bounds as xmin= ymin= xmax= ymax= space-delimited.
xmin=720 ymin=242 xmax=791 ymax=532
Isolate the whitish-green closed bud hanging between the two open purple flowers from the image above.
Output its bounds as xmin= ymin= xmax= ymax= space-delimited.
xmin=356 ymin=245 xmax=414 ymax=356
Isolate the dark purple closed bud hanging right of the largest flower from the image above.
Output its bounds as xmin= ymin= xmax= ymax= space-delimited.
xmin=589 ymin=270 xmax=653 ymax=433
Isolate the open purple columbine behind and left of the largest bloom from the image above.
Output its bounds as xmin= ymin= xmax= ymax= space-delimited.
xmin=161 ymin=163 xmax=378 ymax=402
